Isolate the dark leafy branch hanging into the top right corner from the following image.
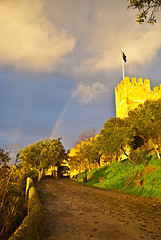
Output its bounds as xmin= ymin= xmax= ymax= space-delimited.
xmin=127 ymin=0 xmax=161 ymax=24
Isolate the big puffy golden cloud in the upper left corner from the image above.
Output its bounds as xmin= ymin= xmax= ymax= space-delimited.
xmin=0 ymin=0 xmax=76 ymax=72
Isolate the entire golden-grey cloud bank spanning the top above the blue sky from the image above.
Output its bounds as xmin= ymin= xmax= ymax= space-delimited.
xmin=0 ymin=0 xmax=161 ymax=75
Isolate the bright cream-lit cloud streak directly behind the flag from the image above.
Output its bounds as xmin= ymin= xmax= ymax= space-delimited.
xmin=85 ymin=25 xmax=161 ymax=71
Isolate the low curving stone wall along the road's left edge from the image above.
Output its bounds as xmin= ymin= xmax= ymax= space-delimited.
xmin=9 ymin=178 xmax=45 ymax=240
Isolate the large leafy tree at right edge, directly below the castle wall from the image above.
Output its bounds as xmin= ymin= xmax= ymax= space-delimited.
xmin=128 ymin=99 xmax=161 ymax=158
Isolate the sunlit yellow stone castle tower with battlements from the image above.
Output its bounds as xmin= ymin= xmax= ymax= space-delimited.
xmin=115 ymin=77 xmax=161 ymax=118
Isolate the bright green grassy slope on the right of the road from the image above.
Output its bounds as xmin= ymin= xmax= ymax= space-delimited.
xmin=78 ymin=155 xmax=161 ymax=198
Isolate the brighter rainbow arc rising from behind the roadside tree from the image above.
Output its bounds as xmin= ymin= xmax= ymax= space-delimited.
xmin=49 ymin=95 xmax=73 ymax=138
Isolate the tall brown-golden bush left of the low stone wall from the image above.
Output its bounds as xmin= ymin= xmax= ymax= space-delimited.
xmin=0 ymin=166 xmax=27 ymax=240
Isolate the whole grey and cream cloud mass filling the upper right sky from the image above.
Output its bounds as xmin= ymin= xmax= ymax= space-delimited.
xmin=46 ymin=0 xmax=161 ymax=77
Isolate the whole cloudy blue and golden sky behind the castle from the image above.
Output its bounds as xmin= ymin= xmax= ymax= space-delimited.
xmin=0 ymin=0 xmax=161 ymax=161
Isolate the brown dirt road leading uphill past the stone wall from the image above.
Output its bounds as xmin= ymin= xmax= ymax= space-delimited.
xmin=36 ymin=178 xmax=161 ymax=240
